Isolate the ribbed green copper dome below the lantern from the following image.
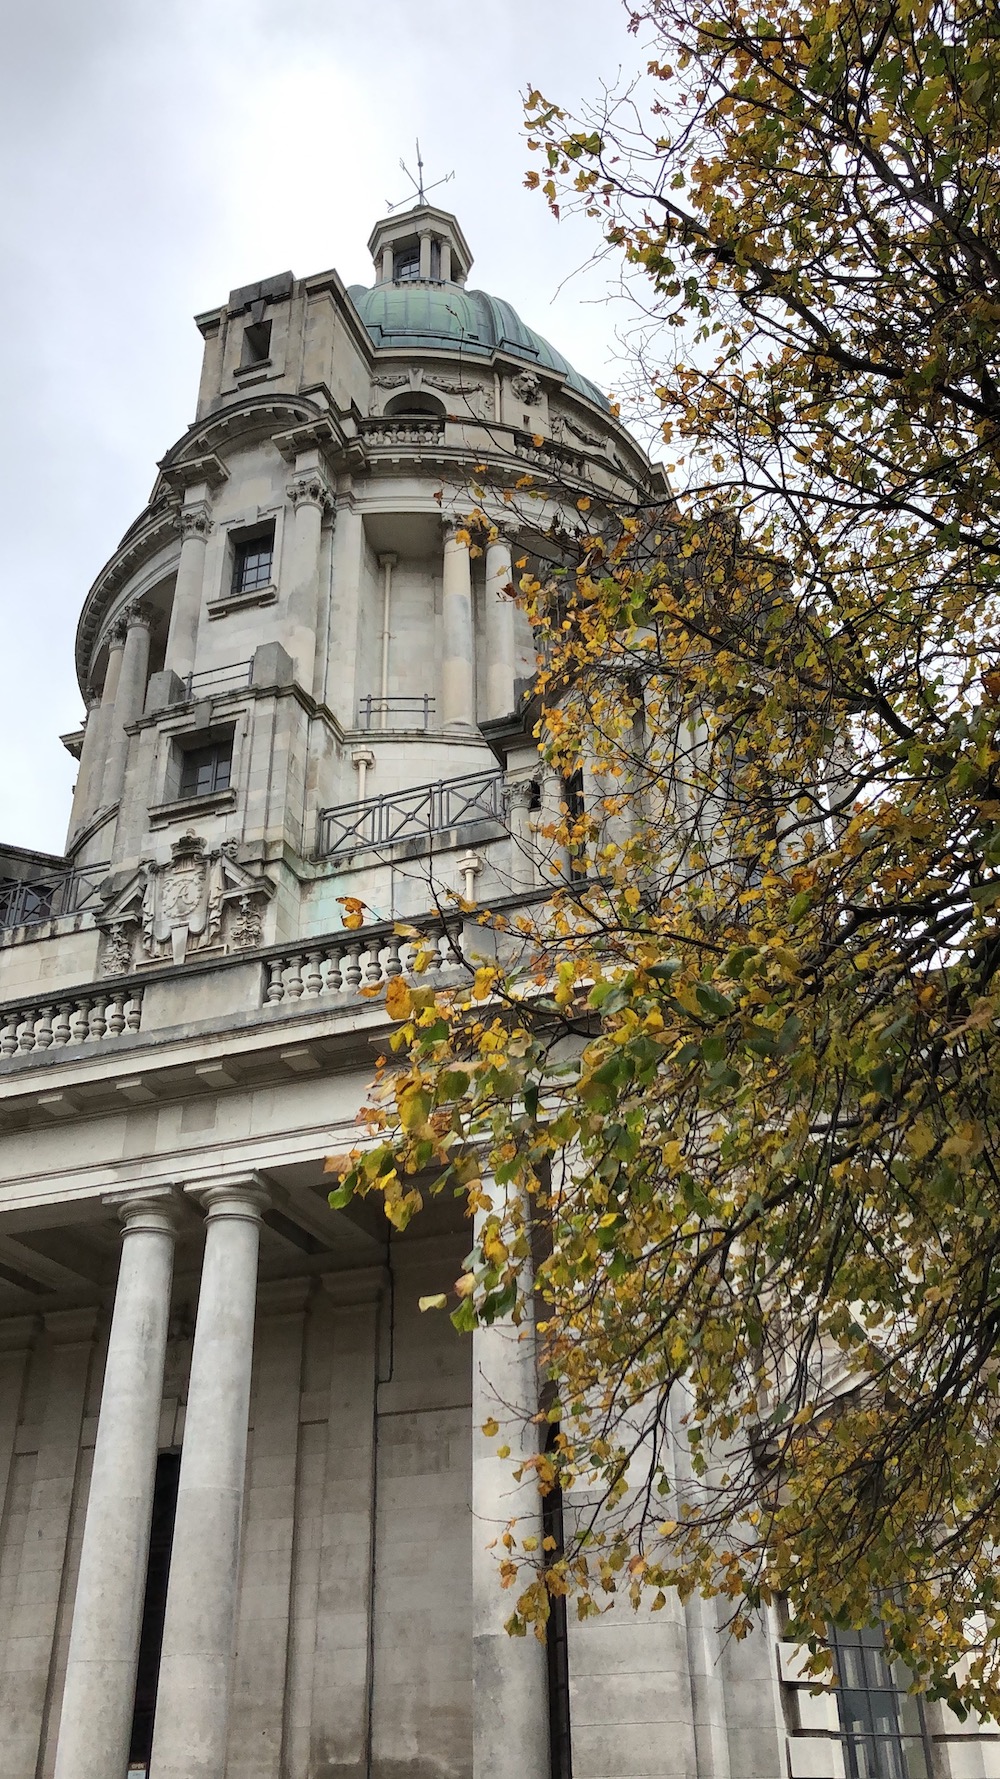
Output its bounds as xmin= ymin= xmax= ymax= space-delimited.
xmin=347 ymin=281 xmax=609 ymax=411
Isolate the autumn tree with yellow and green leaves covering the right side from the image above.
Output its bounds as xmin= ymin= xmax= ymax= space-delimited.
xmin=335 ymin=0 xmax=1000 ymax=1711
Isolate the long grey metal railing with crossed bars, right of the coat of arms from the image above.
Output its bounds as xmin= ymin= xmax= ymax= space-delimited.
xmin=319 ymin=772 xmax=504 ymax=857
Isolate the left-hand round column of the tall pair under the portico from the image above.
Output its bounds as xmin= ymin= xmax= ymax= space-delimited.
xmin=55 ymin=1190 xmax=176 ymax=1779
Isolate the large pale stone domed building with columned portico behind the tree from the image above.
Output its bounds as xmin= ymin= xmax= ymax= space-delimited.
xmin=0 ymin=205 xmax=1000 ymax=1779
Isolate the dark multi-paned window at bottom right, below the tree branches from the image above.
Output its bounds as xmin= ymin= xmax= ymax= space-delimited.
xmin=829 ymin=1628 xmax=932 ymax=1779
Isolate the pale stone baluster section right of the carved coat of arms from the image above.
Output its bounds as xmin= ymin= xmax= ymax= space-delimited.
xmin=263 ymin=920 xmax=463 ymax=1005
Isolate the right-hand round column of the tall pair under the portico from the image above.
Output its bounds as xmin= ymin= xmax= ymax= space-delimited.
xmin=149 ymin=1174 xmax=267 ymax=1779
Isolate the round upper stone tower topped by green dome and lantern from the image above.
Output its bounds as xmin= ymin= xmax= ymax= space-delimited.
xmin=54 ymin=203 xmax=651 ymax=970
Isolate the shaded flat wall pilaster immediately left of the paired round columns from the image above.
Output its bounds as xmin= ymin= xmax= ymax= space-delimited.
xmin=0 ymin=1309 xmax=98 ymax=1779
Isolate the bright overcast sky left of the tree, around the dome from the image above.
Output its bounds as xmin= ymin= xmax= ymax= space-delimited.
xmin=0 ymin=0 xmax=641 ymax=852
